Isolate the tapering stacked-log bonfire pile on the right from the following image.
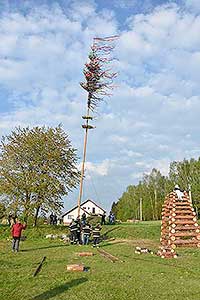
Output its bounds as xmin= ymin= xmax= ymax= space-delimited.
xmin=158 ymin=192 xmax=200 ymax=258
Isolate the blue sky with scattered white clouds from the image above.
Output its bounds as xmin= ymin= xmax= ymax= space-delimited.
xmin=0 ymin=0 xmax=200 ymax=211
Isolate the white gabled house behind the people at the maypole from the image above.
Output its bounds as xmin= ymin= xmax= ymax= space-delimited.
xmin=62 ymin=199 xmax=106 ymax=225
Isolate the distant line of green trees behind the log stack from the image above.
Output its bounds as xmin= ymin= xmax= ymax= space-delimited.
xmin=111 ymin=158 xmax=200 ymax=221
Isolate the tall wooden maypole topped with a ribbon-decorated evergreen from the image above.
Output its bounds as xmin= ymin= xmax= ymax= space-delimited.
xmin=77 ymin=36 xmax=118 ymax=217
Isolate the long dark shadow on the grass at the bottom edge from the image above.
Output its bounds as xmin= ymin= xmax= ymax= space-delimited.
xmin=32 ymin=277 xmax=88 ymax=300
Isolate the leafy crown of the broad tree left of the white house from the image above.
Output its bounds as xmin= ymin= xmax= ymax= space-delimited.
xmin=0 ymin=126 xmax=79 ymax=223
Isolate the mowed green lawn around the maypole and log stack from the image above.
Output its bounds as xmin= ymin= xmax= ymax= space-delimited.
xmin=0 ymin=222 xmax=200 ymax=300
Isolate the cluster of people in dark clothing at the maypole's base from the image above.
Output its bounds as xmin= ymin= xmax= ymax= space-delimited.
xmin=69 ymin=215 xmax=101 ymax=248
